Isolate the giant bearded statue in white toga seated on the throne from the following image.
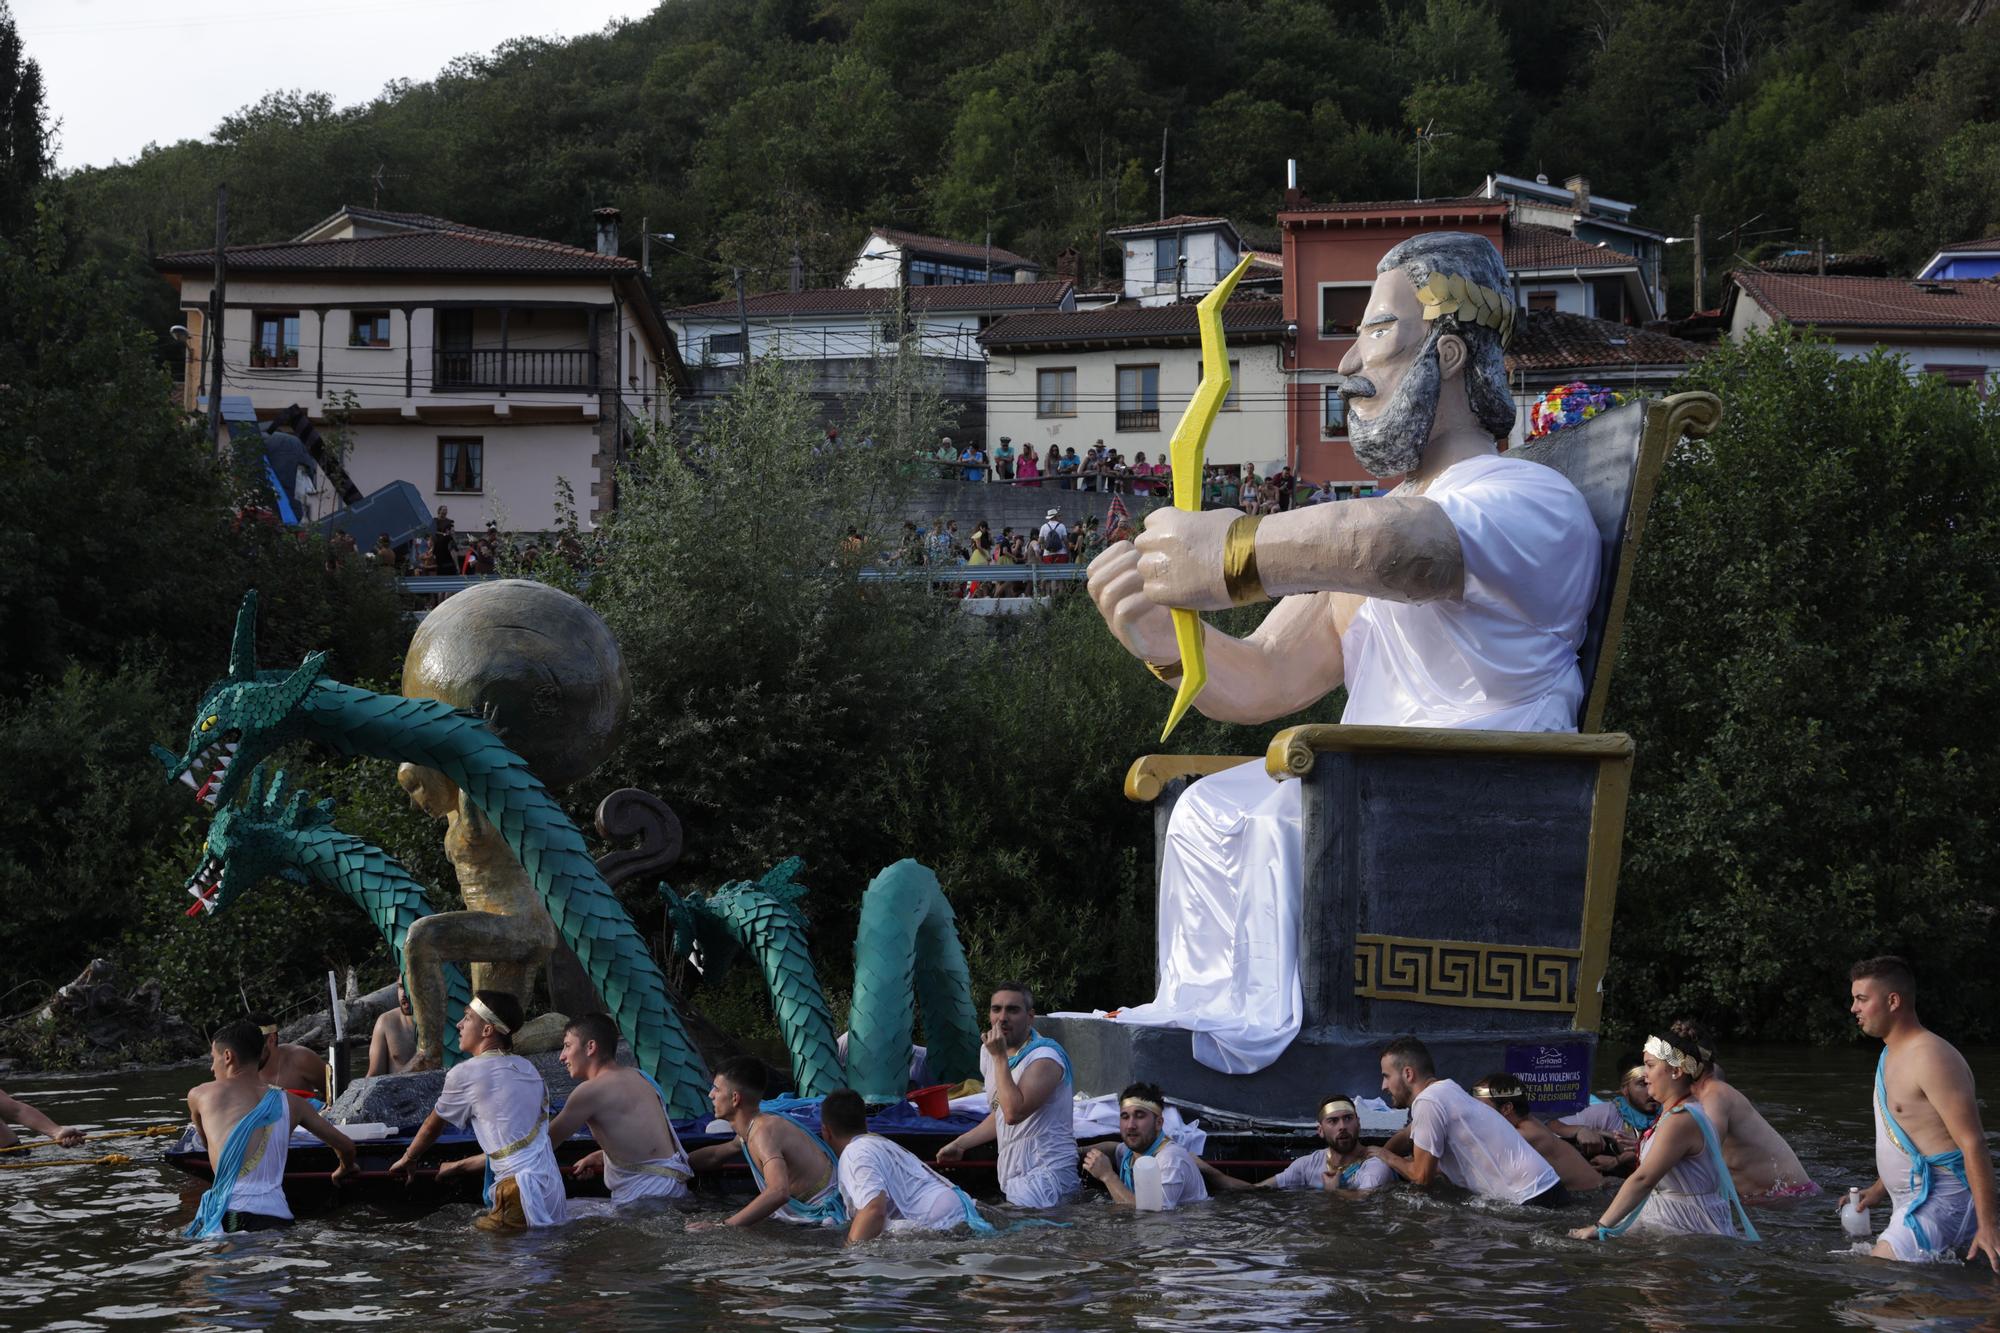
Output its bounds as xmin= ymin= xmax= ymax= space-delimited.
xmin=1090 ymin=232 xmax=1598 ymax=1073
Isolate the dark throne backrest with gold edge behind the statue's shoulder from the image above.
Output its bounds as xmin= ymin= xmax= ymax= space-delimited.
xmin=1508 ymin=394 xmax=1696 ymax=731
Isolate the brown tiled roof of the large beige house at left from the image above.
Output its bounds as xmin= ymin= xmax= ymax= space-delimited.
xmin=154 ymin=217 xmax=638 ymax=272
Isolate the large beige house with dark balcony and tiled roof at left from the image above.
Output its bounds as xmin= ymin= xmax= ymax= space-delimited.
xmin=156 ymin=206 xmax=686 ymax=530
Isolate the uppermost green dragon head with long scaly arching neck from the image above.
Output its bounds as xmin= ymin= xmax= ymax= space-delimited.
xmin=166 ymin=588 xmax=708 ymax=1115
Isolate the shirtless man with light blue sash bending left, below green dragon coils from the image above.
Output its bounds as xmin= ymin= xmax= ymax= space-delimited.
xmin=688 ymin=1055 xmax=848 ymax=1231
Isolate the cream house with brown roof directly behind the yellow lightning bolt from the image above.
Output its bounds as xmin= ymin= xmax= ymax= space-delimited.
xmin=980 ymin=300 xmax=1288 ymax=472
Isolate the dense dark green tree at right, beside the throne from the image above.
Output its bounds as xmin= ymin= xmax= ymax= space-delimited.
xmin=1606 ymin=338 xmax=2000 ymax=1041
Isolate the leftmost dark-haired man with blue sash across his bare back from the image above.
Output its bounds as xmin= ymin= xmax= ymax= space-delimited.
xmin=186 ymin=1019 xmax=354 ymax=1237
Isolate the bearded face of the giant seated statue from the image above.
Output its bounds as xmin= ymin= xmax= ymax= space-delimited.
xmin=1340 ymin=268 xmax=1440 ymax=476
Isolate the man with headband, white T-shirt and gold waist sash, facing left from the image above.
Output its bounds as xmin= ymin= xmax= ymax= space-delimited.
xmin=388 ymin=991 xmax=570 ymax=1231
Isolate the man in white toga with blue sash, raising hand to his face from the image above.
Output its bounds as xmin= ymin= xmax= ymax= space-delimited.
xmin=938 ymin=981 xmax=1082 ymax=1209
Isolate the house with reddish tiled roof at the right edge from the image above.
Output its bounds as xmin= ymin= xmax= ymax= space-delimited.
xmin=1722 ymin=268 xmax=2000 ymax=396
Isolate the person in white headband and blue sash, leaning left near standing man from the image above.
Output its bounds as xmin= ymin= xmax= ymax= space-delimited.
xmin=1570 ymin=1037 xmax=1758 ymax=1241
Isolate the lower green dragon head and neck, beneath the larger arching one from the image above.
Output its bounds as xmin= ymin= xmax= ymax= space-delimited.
xmin=188 ymin=767 xmax=472 ymax=1065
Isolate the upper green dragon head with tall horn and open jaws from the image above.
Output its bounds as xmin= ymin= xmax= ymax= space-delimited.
xmin=152 ymin=588 xmax=326 ymax=809
